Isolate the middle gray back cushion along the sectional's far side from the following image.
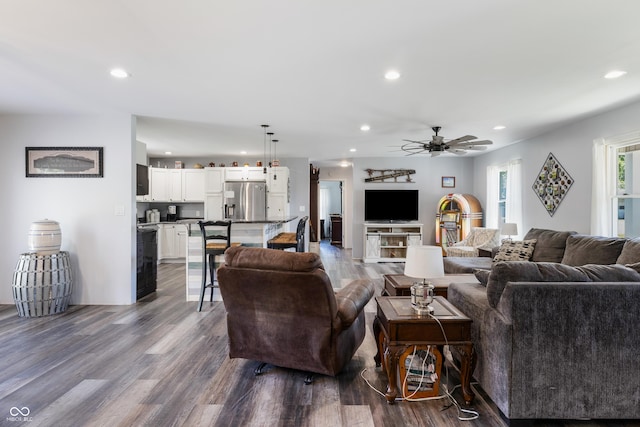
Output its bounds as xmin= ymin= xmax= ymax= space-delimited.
xmin=561 ymin=234 xmax=626 ymax=266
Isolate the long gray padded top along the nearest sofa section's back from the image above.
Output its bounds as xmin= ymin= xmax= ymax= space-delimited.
xmin=487 ymin=261 xmax=640 ymax=308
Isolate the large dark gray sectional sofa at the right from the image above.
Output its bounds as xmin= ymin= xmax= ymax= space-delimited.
xmin=448 ymin=229 xmax=640 ymax=424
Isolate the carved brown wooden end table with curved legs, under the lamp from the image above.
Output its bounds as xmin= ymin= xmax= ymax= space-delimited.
xmin=373 ymin=296 xmax=476 ymax=405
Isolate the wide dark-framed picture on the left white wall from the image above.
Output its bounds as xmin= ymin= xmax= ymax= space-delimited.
xmin=25 ymin=147 xmax=104 ymax=178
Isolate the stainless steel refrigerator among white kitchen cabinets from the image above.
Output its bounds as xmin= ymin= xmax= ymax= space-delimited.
xmin=224 ymin=181 xmax=267 ymax=221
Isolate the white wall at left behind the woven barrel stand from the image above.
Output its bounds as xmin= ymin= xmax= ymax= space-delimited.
xmin=0 ymin=115 xmax=136 ymax=304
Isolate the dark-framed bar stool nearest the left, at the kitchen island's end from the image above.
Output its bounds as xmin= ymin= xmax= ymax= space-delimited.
xmin=198 ymin=221 xmax=240 ymax=311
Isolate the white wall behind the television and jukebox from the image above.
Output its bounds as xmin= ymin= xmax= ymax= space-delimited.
xmin=350 ymin=155 xmax=474 ymax=259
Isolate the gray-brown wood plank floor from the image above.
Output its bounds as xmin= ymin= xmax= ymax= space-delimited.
xmin=0 ymin=244 xmax=639 ymax=427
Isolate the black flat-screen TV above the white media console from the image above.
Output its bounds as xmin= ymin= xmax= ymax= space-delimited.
xmin=364 ymin=190 xmax=418 ymax=222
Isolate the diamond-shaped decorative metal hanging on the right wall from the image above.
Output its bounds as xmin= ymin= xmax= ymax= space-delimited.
xmin=532 ymin=153 xmax=573 ymax=216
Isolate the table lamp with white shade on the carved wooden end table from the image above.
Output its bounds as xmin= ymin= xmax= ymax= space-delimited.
xmin=404 ymin=246 xmax=444 ymax=315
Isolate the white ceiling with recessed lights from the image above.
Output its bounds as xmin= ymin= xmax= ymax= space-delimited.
xmin=0 ymin=0 xmax=640 ymax=165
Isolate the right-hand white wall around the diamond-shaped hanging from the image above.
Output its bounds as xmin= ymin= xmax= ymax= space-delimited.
xmin=473 ymin=102 xmax=640 ymax=235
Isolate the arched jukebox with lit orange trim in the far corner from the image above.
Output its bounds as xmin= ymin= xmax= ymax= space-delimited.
xmin=436 ymin=194 xmax=482 ymax=248
